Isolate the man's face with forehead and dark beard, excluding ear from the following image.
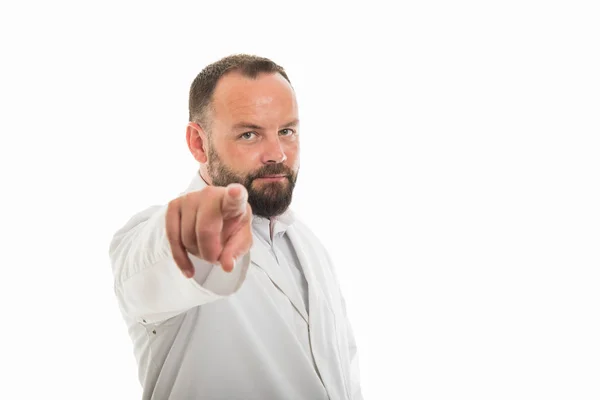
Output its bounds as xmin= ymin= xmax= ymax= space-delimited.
xmin=206 ymin=72 xmax=299 ymax=218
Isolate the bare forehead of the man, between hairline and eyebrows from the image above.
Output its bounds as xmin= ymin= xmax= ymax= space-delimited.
xmin=213 ymin=72 xmax=298 ymax=120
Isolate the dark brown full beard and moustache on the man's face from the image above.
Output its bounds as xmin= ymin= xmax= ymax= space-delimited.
xmin=207 ymin=142 xmax=298 ymax=218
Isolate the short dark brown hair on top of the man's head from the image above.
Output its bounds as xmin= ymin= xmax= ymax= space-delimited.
xmin=189 ymin=54 xmax=291 ymax=129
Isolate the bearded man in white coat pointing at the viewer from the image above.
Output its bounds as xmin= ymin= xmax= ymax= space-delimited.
xmin=110 ymin=55 xmax=362 ymax=400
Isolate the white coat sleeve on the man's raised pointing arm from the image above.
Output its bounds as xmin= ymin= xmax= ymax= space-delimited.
xmin=109 ymin=205 xmax=250 ymax=324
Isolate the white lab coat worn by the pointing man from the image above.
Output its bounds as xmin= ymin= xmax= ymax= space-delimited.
xmin=110 ymin=174 xmax=362 ymax=400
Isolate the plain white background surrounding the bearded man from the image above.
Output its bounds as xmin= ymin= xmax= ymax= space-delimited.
xmin=0 ymin=1 xmax=600 ymax=400
